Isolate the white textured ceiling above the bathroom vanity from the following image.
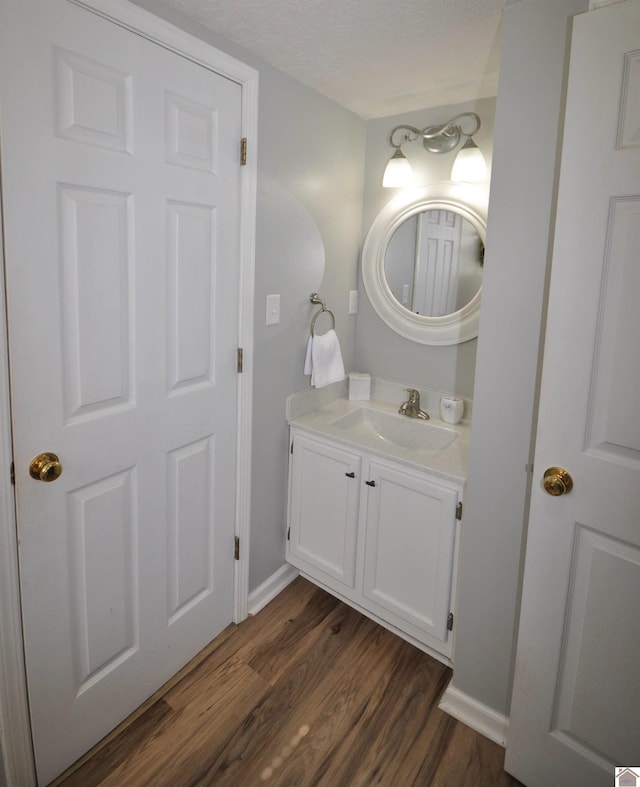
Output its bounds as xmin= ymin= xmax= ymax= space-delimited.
xmin=158 ymin=0 xmax=518 ymax=119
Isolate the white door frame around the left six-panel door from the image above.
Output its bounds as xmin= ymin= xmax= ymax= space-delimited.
xmin=0 ymin=0 xmax=258 ymax=787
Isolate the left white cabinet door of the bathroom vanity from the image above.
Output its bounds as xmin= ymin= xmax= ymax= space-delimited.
xmin=287 ymin=434 xmax=362 ymax=588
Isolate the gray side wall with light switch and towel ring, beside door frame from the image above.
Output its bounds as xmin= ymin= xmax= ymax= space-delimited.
xmin=135 ymin=0 xmax=365 ymax=590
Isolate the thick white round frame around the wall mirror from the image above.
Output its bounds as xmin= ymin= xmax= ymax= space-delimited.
xmin=362 ymin=186 xmax=489 ymax=345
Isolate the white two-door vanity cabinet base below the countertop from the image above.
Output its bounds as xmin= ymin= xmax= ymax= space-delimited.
xmin=287 ymin=428 xmax=462 ymax=663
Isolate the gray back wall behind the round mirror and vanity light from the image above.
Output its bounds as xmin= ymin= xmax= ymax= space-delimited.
xmin=356 ymin=98 xmax=495 ymax=398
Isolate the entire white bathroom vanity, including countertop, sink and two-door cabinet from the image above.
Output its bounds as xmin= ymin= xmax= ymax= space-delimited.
xmin=287 ymin=399 xmax=469 ymax=664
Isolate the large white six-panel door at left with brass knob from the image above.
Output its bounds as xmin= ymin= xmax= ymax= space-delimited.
xmin=0 ymin=0 xmax=241 ymax=783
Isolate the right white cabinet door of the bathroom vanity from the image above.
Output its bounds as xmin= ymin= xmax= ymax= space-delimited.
xmin=363 ymin=461 xmax=458 ymax=641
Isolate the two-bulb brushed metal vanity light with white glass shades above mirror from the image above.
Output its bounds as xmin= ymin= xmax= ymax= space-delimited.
xmin=382 ymin=112 xmax=487 ymax=188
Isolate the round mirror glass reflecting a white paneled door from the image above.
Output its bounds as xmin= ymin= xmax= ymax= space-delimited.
xmin=385 ymin=209 xmax=484 ymax=317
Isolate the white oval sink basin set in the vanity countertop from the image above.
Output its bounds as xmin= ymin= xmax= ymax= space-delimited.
xmin=331 ymin=407 xmax=458 ymax=453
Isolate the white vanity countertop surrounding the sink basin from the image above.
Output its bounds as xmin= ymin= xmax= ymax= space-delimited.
xmin=289 ymin=398 xmax=471 ymax=484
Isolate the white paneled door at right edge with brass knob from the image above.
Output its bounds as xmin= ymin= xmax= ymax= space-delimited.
xmin=506 ymin=0 xmax=640 ymax=787
